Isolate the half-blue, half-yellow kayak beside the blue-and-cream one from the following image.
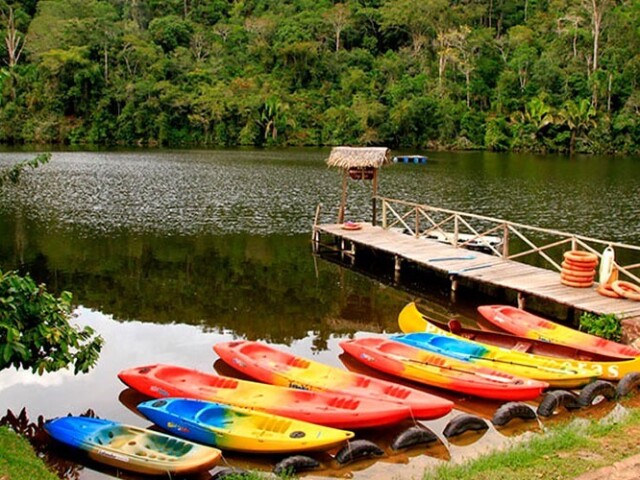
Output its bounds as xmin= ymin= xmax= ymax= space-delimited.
xmin=137 ymin=398 xmax=354 ymax=453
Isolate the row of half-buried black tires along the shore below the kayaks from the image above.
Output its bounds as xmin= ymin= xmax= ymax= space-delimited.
xmin=210 ymin=372 xmax=640 ymax=480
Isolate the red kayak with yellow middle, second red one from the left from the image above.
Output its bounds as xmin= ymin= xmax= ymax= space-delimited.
xmin=213 ymin=340 xmax=453 ymax=419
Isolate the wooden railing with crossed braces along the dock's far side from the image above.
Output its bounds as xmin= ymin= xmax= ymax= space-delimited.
xmin=373 ymin=196 xmax=640 ymax=283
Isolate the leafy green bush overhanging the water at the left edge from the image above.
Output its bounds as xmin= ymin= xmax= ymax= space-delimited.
xmin=0 ymin=271 xmax=102 ymax=374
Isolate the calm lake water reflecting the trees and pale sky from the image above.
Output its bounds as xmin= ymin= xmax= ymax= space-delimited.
xmin=0 ymin=149 xmax=640 ymax=479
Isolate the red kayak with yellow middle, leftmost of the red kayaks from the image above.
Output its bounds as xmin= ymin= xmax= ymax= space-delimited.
xmin=118 ymin=365 xmax=411 ymax=429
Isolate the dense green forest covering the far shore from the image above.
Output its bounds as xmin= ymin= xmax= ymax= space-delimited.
xmin=0 ymin=0 xmax=640 ymax=154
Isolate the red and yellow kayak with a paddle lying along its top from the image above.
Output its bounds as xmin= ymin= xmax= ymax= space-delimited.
xmin=340 ymin=337 xmax=549 ymax=401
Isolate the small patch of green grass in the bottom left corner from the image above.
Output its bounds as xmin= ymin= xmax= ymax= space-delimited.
xmin=0 ymin=427 xmax=58 ymax=480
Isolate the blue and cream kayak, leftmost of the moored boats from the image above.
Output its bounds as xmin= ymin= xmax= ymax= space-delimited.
xmin=44 ymin=416 xmax=221 ymax=475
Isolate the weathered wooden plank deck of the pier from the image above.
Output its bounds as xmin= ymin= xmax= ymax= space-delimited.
xmin=314 ymin=223 xmax=640 ymax=328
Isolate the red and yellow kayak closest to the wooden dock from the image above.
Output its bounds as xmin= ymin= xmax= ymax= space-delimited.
xmin=478 ymin=305 xmax=640 ymax=358
